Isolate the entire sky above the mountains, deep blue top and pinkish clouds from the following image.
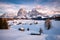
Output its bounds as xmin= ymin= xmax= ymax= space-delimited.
xmin=0 ymin=0 xmax=60 ymax=14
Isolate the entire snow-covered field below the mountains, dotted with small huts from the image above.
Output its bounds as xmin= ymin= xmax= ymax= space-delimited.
xmin=0 ymin=20 xmax=60 ymax=40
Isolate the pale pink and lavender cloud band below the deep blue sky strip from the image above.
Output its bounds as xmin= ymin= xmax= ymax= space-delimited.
xmin=0 ymin=0 xmax=60 ymax=15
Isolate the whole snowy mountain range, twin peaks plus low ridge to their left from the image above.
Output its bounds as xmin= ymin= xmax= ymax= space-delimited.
xmin=2 ymin=8 xmax=47 ymax=18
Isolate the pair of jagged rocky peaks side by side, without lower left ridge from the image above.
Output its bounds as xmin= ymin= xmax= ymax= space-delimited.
xmin=17 ymin=8 xmax=47 ymax=18
